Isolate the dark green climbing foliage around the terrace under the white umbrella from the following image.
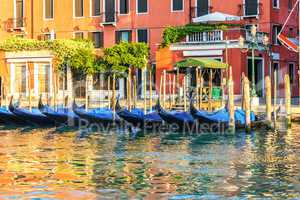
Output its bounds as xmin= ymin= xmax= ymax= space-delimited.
xmin=160 ymin=23 xmax=240 ymax=48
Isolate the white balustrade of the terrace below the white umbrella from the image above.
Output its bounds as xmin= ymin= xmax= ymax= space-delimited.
xmin=187 ymin=30 xmax=223 ymax=43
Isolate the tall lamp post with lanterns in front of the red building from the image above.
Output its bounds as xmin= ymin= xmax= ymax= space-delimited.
xmin=239 ymin=25 xmax=258 ymax=97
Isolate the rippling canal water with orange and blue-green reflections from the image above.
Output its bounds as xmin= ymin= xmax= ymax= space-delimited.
xmin=0 ymin=127 xmax=300 ymax=200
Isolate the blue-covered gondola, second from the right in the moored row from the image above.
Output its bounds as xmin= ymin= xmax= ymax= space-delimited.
xmin=155 ymin=100 xmax=196 ymax=131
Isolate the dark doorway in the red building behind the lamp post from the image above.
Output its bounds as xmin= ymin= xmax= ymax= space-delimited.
xmin=248 ymin=58 xmax=264 ymax=97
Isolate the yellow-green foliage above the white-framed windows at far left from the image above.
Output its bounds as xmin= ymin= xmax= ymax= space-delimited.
xmin=0 ymin=37 xmax=95 ymax=73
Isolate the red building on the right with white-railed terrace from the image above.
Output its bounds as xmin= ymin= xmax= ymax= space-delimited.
xmin=156 ymin=0 xmax=299 ymax=97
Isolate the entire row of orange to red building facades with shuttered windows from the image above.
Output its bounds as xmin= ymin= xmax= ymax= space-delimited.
xmin=0 ymin=0 xmax=298 ymax=100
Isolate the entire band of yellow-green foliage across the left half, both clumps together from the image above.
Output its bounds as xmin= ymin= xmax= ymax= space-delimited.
xmin=0 ymin=37 xmax=149 ymax=76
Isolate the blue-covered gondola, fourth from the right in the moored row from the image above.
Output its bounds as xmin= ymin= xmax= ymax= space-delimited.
xmin=72 ymin=100 xmax=121 ymax=125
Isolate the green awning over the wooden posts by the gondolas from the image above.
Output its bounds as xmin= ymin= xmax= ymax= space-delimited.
xmin=174 ymin=58 xmax=228 ymax=69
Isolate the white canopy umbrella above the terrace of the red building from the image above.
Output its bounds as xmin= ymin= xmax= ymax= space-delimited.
xmin=193 ymin=12 xmax=241 ymax=23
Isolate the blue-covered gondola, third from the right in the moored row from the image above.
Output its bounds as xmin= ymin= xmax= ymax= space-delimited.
xmin=116 ymin=99 xmax=163 ymax=129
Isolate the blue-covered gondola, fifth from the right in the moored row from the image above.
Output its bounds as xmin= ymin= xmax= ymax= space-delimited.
xmin=38 ymin=98 xmax=80 ymax=126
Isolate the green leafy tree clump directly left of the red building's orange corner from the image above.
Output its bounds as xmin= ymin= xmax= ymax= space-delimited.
xmin=98 ymin=42 xmax=149 ymax=76
